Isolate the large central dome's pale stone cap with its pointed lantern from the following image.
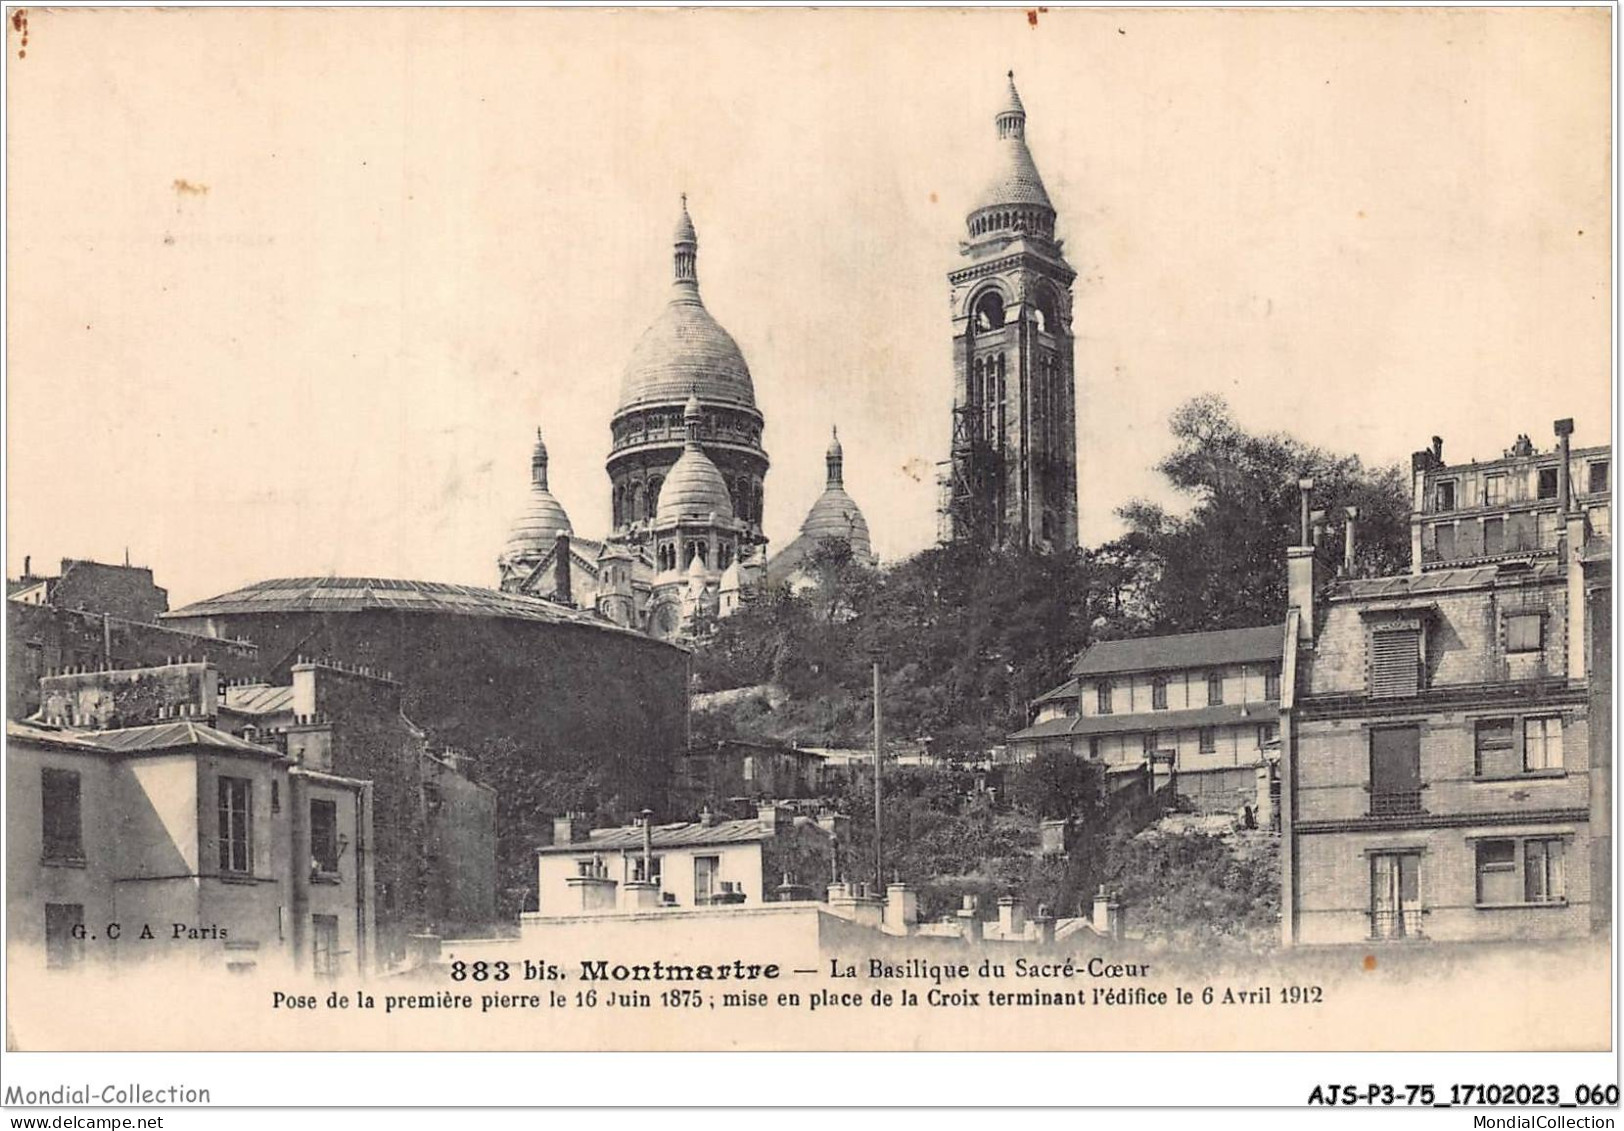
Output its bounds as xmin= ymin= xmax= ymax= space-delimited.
xmin=615 ymin=202 xmax=755 ymax=413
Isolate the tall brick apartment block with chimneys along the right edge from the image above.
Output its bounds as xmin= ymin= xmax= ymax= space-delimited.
xmin=1281 ymin=421 xmax=1611 ymax=944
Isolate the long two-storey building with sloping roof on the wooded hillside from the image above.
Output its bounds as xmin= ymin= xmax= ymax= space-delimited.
xmin=1009 ymin=624 xmax=1285 ymax=813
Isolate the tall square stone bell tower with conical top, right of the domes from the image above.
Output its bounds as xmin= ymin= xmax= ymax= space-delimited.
xmin=942 ymin=72 xmax=1077 ymax=551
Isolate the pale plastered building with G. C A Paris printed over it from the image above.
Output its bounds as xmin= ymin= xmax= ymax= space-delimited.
xmin=6 ymin=717 xmax=375 ymax=977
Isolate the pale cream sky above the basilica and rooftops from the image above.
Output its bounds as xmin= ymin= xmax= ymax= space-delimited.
xmin=6 ymin=8 xmax=1613 ymax=606
